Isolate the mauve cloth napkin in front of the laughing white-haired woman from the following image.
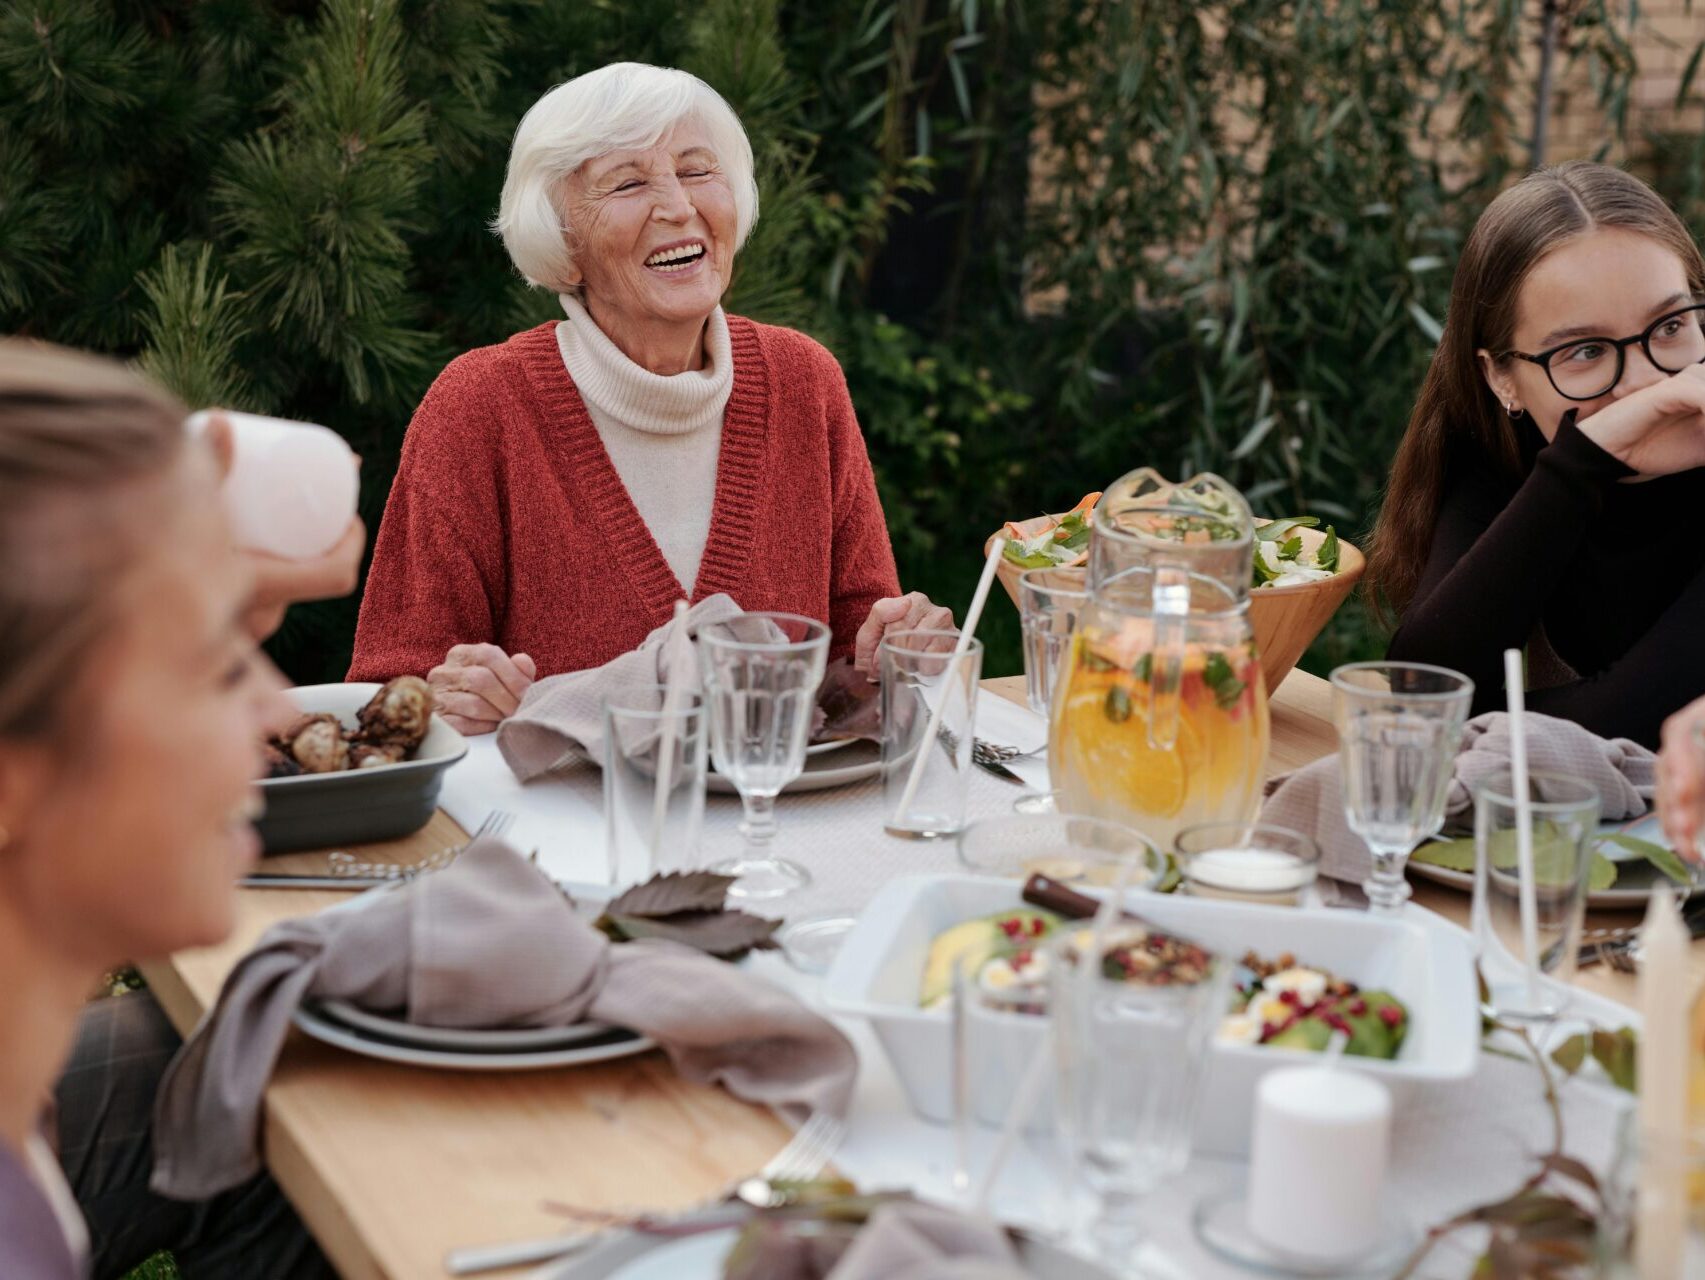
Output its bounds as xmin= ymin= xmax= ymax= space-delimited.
xmin=498 ymin=595 xmax=740 ymax=782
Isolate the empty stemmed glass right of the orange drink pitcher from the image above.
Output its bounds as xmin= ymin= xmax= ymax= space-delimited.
xmin=1332 ymin=663 xmax=1475 ymax=915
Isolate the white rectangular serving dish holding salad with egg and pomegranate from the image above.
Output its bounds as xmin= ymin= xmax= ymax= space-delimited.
xmin=824 ymin=874 xmax=1480 ymax=1156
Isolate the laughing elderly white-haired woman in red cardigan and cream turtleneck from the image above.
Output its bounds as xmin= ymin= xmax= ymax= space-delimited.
xmin=350 ymin=63 xmax=953 ymax=733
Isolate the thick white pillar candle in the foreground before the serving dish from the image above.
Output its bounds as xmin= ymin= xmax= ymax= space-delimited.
xmin=1248 ymin=1065 xmax=1391 ymax=1260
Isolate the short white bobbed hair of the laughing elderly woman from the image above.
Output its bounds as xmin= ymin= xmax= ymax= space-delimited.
xmin=491 ymin=63 xmax=757 ymax=291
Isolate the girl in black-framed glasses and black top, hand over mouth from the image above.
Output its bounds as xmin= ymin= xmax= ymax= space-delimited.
xmin=1367 ymin=162 xmax=1705 ymax=747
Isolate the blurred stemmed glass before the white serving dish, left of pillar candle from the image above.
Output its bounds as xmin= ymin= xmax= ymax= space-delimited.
xmin=1049 ymin=912 xmax=1231 ymax=1275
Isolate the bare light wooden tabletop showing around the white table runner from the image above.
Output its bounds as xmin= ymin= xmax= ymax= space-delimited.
xmin=132 ymin=672 xmax=1677 ymax=1280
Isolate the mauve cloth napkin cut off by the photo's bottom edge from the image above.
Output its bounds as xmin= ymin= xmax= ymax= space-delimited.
xmin=829 ymin=1202 xmax=1025 ymax=1280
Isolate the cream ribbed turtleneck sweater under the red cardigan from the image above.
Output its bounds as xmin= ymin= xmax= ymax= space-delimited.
xmin=556 ymin=293 xmax=735 ymax=597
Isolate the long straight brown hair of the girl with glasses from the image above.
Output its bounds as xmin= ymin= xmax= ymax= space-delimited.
xmin=1362 ymin=160 xmax=1705 ymax=622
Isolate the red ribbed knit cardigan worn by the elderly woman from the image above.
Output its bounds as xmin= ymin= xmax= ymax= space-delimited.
xmin=348 ymin=315 xmax=900 ymax=680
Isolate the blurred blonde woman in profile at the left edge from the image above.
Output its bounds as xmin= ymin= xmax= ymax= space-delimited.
xmin=0 ymin=341 xmax=332 ymax=1280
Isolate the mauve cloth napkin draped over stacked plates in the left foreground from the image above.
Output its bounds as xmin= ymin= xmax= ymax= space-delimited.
xmin=150 ymin=840 xmax=858 ymax=1200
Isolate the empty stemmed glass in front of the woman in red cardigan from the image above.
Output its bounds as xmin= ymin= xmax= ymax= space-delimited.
xmin=697 ymin=614 xmax=829 ymax=898
